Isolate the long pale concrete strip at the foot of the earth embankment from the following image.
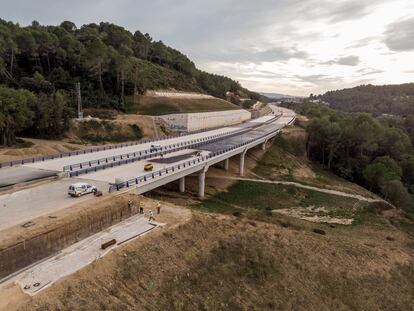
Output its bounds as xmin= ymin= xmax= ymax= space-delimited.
xmin=16 ymin=216 xmax=157 ymax=296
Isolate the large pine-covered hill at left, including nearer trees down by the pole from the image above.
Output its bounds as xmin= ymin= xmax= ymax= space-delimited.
xmin=0 ymin=19 xmax=259 ymax=145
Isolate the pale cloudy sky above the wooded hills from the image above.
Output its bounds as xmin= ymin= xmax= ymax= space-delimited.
xmin=0 ymin=0 xmax=414 ymax=96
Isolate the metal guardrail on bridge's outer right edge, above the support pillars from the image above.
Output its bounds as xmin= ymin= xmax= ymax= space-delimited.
xmin=109 ymin=121 xmax=286 ymax=192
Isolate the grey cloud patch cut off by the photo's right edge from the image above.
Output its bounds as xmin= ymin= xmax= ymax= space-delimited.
xmin=384 ymin=17 xmax=414 ymax=51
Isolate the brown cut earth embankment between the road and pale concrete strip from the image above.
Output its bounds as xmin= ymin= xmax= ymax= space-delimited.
xmin=0 ymin=194 xmax=151 ymax=279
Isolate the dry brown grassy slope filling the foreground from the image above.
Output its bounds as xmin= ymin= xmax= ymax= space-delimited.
xmin=14 ymin=213 xmax=414 ymax=310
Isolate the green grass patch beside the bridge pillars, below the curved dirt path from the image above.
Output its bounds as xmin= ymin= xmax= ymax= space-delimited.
xmin=193 ymin=181 xmax=368 ymax=223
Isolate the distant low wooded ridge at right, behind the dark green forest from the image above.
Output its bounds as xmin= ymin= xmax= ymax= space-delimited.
xmin=318 ymin=83 xmax=414 ymax=116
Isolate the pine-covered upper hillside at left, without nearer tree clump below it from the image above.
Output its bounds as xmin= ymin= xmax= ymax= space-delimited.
xmin=0 ymin=19 xmax=259 ymax=110
